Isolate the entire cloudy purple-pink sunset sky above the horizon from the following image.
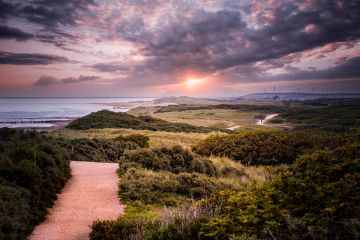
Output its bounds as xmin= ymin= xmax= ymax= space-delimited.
xmin=0 ymin=0 xmax=360 ymax=97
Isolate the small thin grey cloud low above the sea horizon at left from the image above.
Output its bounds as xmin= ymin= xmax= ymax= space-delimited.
xmin=34 ymin=75 xmax=100 ymax=87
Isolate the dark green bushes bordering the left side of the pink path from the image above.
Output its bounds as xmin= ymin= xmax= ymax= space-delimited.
xmin=0 ymin=128 xmax=70 ymax=240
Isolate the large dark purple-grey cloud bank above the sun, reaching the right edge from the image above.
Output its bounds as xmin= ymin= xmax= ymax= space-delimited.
xmin=118 ymin=0 xmax=360 ymax=76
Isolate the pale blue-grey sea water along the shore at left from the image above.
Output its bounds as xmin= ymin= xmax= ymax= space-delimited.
xmin=0 ymin=98 xmax=153 ymax=128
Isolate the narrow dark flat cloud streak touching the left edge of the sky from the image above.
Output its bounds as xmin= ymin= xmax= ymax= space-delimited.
xmin=0 ymin=51 xmax=69 ymax=65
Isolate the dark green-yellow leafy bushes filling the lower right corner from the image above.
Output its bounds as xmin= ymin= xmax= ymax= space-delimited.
xmin=200 ymin=145 xmax=360 ymax=239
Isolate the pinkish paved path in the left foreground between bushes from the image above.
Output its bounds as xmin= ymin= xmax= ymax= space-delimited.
xmin=29 ymin=161 xmax=123 ymax=240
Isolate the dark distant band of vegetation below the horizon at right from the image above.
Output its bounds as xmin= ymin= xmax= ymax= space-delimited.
xmin=156 ymin=99 xmax=360 ymax=132
